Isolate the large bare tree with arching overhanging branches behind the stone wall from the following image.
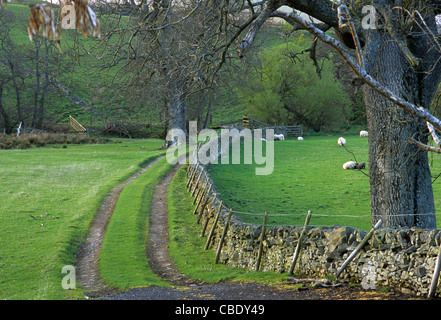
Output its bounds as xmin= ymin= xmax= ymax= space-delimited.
xmin=240 ymin=0 xmax=441 ymax=228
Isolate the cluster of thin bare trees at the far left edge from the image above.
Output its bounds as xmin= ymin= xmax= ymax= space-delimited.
xmin=0 ymin=10 xmax=58 ymax=133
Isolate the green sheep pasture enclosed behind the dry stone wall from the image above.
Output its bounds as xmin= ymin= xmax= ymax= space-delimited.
xmin=210 ymin=135 xmax=441 ymax=230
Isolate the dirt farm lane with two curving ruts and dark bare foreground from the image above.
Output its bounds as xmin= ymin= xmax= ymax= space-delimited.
xmin=77 ymin=158 xmax=422 ymax=300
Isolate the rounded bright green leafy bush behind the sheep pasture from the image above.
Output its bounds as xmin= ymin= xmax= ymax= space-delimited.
xmin=238 ymin=37 xmax=351 ymax=131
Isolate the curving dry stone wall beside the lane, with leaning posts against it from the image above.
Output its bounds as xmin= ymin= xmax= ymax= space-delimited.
xmin=188 ymin=166 xmax=441 ymax=296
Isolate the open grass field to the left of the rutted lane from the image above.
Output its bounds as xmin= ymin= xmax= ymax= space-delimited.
xmin=0 ymin=140 xmax=163 ymax=299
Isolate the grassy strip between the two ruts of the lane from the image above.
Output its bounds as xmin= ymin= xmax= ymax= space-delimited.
xmin=100 ymin=157 xmax=172 ymax=289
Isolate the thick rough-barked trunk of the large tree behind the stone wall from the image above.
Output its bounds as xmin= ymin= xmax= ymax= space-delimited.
xmin=364 ymin=31 xmax=436 ymax=229
